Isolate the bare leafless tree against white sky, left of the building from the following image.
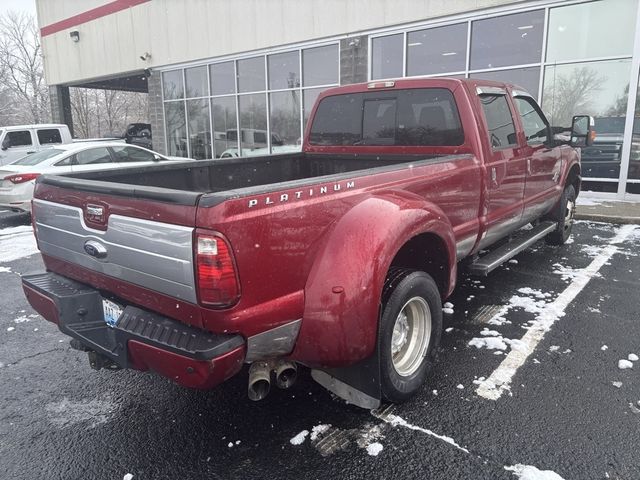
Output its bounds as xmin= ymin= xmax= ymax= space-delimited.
xmin=0 ymin=11 xmax=50 ymax=123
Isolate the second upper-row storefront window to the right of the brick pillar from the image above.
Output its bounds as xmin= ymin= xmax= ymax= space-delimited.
xmin=407 ymin=23 xmax=467 ymax=76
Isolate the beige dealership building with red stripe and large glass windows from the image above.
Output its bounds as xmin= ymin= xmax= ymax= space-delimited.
xmin=37 ymin=0 xmax=640 ymax=199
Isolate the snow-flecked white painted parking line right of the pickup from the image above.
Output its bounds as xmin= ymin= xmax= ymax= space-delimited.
xmin=476 ymin=225 xmax=637 ymax=400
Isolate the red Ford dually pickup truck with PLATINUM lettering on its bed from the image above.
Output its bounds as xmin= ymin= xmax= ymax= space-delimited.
xmin=23 ymin=78 xmax=593 ymax=408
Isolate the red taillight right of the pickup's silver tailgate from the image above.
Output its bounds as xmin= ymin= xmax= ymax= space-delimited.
xmin=195 ymin=233 xmax=240 ymax=307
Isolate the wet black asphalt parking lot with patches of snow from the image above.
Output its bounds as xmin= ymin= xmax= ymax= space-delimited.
xmin=0 ymin=213 xmax=640 ymax=480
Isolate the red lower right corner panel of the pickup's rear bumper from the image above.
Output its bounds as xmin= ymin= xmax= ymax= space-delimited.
xmin=128 ymin=340 xmax=245 ymax=389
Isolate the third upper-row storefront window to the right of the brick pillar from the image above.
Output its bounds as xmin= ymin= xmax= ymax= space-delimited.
xmin=471 ymin=10 xmax=544 ymax=70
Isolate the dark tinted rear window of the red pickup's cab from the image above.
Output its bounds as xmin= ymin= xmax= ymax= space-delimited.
xmin=309 ymin=88 xmax=464 ymax=146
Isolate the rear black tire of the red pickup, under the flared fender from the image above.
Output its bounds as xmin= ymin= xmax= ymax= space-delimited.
xmin=378 ymin=268 xmax=442 ymax=402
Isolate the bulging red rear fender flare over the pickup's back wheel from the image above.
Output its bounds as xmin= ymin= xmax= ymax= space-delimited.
xmin=292 ymin=192 xmax=456 ymax=367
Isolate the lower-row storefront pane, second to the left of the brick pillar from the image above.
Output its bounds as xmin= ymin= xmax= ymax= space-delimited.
xmin=269 ymin=90 xmax=302 ymax=153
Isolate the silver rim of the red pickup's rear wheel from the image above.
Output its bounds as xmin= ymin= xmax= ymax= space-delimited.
xmin=391 ymin=297 xmax=431 ymax=377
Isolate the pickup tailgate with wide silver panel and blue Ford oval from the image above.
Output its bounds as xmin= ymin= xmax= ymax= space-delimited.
xmin=33 ymin=177 xmax=200 ymax=325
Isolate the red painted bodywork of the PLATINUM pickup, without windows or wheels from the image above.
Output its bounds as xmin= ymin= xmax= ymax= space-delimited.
xmin=30 ymin=79 xmax=578 ymax=373
